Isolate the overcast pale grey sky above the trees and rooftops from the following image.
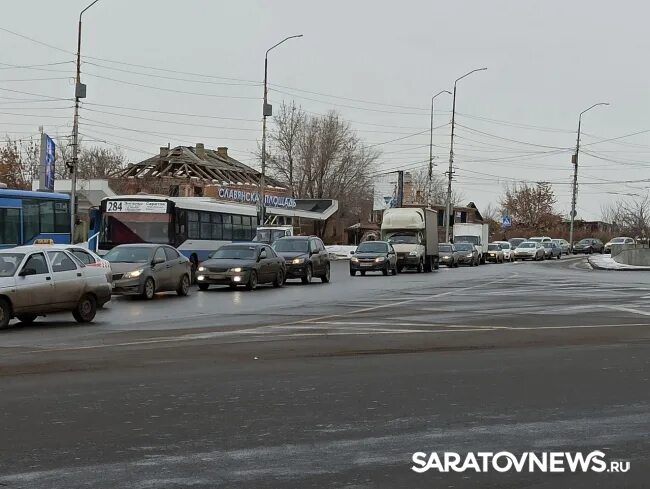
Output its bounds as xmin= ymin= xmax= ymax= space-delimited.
xmin=0 ymin=0 xmax=650 ymax=219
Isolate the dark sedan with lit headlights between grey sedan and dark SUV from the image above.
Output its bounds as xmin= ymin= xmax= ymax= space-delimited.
xmin=196 ymin=243 xmax=286 ymax=290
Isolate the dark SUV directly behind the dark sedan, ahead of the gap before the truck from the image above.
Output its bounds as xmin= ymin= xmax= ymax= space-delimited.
xmin=271 ymin=236 xmax=330 ymax=284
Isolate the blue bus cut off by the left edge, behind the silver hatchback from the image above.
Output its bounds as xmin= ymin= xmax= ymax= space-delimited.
xmin=0 ymin=188 xmax=71 ymax=249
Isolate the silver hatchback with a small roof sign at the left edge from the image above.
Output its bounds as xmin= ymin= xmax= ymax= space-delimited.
xmin=0 ymin=246 xmax=111 ymax=329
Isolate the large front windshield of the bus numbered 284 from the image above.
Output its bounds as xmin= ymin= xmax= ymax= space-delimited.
xmin=99 ymin=212 xmax=172 ymax=246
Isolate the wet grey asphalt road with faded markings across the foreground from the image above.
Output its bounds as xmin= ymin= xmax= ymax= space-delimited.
xmin=0 ymin=259 xmax=650 ymax=489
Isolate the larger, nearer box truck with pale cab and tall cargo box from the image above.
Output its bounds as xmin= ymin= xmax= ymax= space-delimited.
xmin=381 ymin=207 xmax=440 ymax=273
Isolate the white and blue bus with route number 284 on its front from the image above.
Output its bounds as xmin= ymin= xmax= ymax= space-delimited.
xmin=88 ymin=195 xmax=257 ymax=266
